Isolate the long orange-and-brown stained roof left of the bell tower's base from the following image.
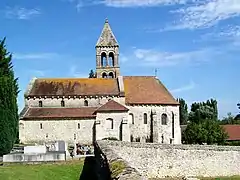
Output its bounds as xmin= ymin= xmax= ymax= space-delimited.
xmin=29 ymin=78 xmax=119 ymax=96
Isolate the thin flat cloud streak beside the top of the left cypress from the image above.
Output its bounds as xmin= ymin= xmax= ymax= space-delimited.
xmin=13 ymin=53 xmax=60 ymax=60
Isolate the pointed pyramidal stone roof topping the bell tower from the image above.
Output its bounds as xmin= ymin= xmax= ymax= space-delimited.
xmin=96 ymin=19 xmax=118 ymax=47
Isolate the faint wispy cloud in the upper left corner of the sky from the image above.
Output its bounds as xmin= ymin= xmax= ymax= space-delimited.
xmin=5 ymin=7 xmax=41 ymax=20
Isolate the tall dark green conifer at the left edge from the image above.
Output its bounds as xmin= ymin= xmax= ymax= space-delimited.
xmin=0 ymin=38 xmax=19 ymax=155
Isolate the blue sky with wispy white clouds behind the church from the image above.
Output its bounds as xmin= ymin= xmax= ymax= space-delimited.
xmin=0 ymin=0 xmax=240 ymax=117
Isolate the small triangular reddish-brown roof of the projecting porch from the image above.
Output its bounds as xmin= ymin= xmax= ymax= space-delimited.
xmin=96 ymin=100 xmax=129 ymax=112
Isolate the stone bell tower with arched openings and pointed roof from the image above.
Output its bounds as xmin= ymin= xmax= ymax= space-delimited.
xmin=95 ymin=19 xmax=120 ymax=78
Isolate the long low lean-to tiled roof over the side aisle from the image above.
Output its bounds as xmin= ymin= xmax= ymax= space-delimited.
xmin=22 ymin=107 xmax=97 ymax=120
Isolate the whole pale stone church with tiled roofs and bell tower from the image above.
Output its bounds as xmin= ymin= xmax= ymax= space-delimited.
xmin=19 ymin=20 xmax=181 ymax=144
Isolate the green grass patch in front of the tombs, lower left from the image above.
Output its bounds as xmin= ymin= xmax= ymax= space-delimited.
xmin=0 ymin=160 xmax=84 ymax=180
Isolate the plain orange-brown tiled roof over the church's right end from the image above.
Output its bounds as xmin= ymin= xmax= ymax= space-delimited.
xmin=123 ymin=76 xmax=179 ymax=105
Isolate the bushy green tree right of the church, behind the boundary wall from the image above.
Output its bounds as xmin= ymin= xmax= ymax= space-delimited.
xmin=183 ymin=99 xmax=227 ymax=144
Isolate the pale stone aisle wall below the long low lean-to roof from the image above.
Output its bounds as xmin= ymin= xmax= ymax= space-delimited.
xmin=19 ymin=119 xmax=95 ymax=144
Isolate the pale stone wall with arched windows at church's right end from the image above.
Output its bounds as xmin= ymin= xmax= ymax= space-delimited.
xmin=128 ymin=106 xmax=181 ymax=144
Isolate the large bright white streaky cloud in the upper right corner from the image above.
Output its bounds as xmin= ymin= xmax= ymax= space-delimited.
xmin=166 ymin=0 xmax=240 ymax=30
